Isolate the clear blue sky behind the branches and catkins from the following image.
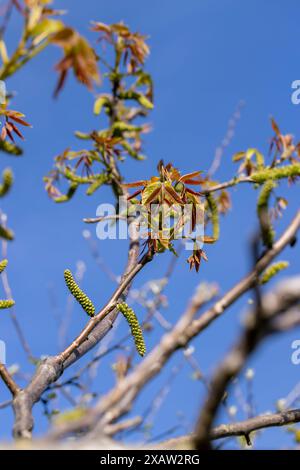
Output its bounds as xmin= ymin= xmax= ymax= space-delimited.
xmin=0 ymin=0 xmax=300 ymax=448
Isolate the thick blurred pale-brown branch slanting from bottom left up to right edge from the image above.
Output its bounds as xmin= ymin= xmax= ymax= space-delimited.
xmin=49 ymin=211 xmax=300 ymax=436
